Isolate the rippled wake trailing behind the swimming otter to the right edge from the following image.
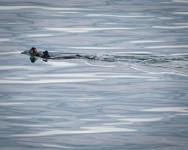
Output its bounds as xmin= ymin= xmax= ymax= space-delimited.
xmin=22 ymin=51 xmax=188 ymax=77
